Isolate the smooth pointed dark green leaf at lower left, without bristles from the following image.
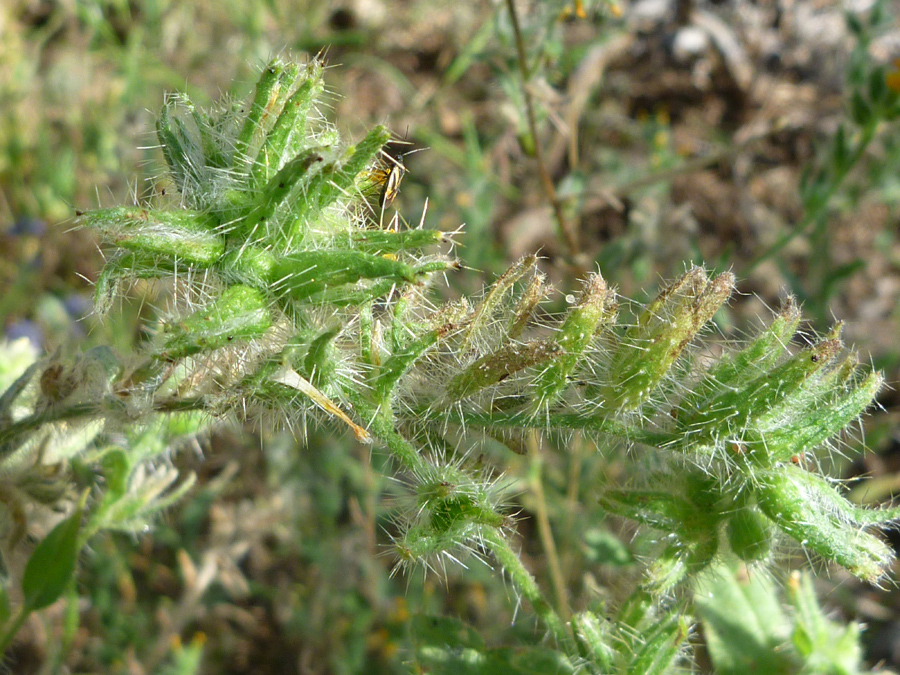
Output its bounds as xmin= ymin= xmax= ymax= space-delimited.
xmin=22 ymin=503 xmax=84 ymax=611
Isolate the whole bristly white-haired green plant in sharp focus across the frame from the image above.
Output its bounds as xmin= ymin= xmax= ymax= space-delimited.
xmin=0 ymin=60 xmax=900 ymax=672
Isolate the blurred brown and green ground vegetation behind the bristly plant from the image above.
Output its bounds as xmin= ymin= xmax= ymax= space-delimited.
xmin=0 ymin=0 xmax=900 ymax=674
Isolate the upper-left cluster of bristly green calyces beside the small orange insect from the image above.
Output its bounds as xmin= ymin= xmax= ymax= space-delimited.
xmin=79 ymin=59 xmax=455 ymax=448
